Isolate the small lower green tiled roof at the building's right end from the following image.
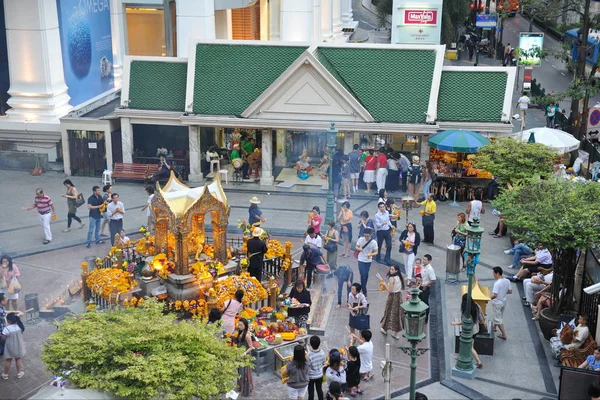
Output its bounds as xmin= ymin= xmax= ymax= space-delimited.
xmin=437 ymin=71 xmax=507 ymax=122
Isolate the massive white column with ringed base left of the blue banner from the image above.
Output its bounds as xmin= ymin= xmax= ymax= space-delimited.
xmin=4 ymin=0 xmax=72 ymax=122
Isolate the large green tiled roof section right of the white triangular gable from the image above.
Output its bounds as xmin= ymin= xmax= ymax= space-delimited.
xmin=316 ymin=47 xmax=435 ymax=123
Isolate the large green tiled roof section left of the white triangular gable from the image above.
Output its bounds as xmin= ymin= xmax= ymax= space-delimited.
xmin=194 ymin=44 xmax=306 ymax=115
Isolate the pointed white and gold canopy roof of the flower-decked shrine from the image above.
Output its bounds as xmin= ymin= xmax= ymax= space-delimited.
xmin=158 ymin=172 xmax=227 ymax=218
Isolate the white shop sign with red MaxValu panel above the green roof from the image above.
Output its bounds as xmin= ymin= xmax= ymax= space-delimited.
xmin=392 ymin=0 xmax=442 ymax=44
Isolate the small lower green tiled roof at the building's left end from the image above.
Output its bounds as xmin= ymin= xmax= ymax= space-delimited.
xmin=129 ymin=61 xmax=187 ymax=112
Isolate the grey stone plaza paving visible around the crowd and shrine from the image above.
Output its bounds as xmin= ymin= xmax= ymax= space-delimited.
xmin=0 ymin=171 xmax=559 ymax=399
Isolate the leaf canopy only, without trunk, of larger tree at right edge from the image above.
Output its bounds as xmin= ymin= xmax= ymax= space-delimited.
xmin=492 ymin=179 xmax=600 ymax=250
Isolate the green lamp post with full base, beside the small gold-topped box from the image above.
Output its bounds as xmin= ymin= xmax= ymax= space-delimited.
xmin=452 ymin=217 xmax=484 ymax=379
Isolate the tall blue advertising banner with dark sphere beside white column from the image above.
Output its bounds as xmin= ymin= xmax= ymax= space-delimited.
xmin=57 ymin=0 xmax=114 ymax=106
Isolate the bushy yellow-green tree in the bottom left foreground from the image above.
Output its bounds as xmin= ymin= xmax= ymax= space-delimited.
xmin=42 ymin=300 xmax=250 ymax=399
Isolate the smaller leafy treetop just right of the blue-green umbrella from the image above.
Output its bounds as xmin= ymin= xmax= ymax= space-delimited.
xmin=473 ymin=138 xmax=557 ymax=185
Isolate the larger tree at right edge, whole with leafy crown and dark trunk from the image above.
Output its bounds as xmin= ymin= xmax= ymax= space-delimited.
xmin=493 ymin=179 xmax=600 ymax=316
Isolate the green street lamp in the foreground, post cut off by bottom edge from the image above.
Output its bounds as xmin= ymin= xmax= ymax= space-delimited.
xmin=400 ymin=288 xmax=429 ymax=400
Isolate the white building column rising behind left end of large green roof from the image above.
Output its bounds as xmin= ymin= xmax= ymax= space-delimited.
xmin=176 ymin=0 xmax=215 ymax=57
